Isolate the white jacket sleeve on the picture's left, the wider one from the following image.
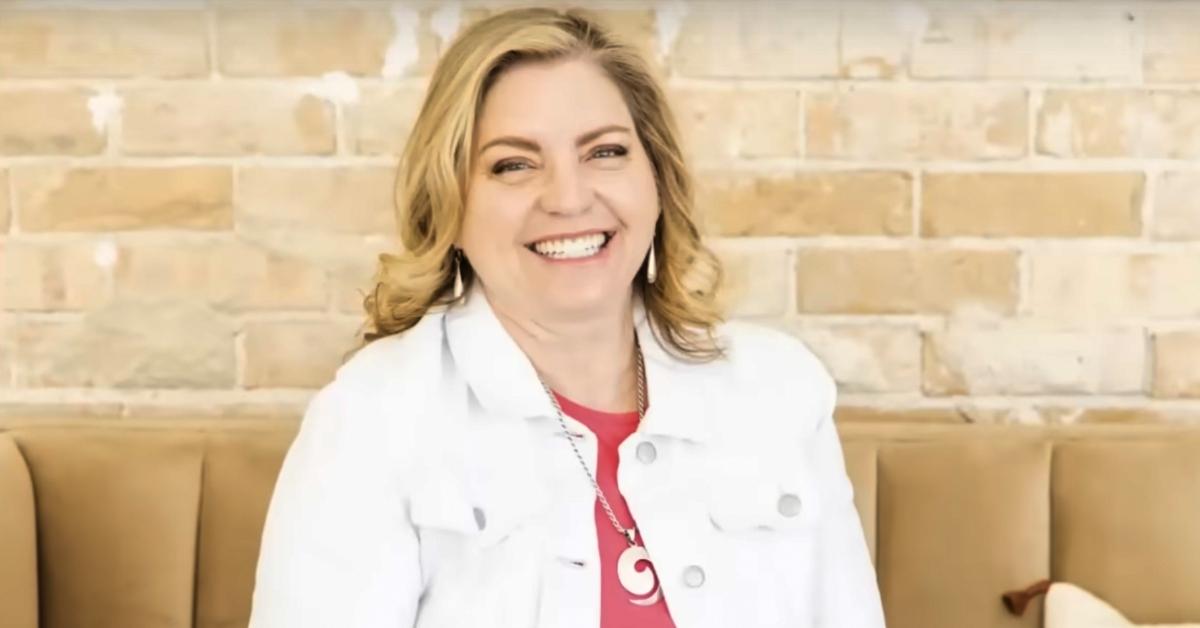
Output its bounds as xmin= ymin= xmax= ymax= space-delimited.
xmin=250 ymin=379 xmax=421 ymax=628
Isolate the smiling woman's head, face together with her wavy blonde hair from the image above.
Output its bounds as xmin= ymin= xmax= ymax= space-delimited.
xmin=352 ymin=4 xmax=722 ymax=360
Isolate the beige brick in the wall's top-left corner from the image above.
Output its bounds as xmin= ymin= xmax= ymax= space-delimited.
xmin=0 ymin=8 xmax=209 ymax=78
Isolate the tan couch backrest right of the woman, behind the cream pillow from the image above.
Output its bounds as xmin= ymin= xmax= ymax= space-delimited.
xmin=841 ymin=425 xmax=1200 ymax=627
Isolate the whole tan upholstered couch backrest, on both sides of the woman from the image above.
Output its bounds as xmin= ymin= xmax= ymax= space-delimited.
xmin=0 ymin=419 xmax=1200 ymax=628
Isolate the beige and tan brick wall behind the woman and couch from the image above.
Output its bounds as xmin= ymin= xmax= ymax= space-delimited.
xmin=0 ymin=0 xmax=1200 ymax=423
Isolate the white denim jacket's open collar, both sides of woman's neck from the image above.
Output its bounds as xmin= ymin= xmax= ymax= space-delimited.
xmin=443 ymin=281 xmax=720 ymax=442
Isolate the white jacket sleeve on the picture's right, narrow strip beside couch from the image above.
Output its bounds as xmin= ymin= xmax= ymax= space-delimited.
xmin=809 ymin=370 xmax=884 ymax=628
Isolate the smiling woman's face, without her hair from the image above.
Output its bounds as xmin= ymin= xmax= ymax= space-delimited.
xmin=456 ymin=60 xmax=659 ymax=318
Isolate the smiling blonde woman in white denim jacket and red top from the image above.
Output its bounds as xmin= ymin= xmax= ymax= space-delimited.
xmin=251 ymin=8 xmax=883 ymax=628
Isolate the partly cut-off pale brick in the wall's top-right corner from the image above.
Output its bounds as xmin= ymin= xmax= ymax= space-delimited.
xmin=1142 ymin=2 xmax=1200 ymax=82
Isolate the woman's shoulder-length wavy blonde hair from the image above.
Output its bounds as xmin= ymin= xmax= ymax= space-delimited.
xmin=352 ymin=7 xmax=725 ymax=361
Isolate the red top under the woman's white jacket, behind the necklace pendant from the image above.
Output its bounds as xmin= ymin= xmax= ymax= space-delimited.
xmin=554 ymin=393 xmax=674 ymax=628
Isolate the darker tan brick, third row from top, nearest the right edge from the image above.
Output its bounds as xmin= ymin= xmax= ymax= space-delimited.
xmin=920 ymin=172 xmax=1144 ymax=238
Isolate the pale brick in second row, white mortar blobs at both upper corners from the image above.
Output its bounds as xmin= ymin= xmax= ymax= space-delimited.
xmin=121 ymin=83 xmax=336 ymax=155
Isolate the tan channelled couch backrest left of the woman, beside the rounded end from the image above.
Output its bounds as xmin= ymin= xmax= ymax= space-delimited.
xmin=0 ymin=420 xmax=296 ymax=628
